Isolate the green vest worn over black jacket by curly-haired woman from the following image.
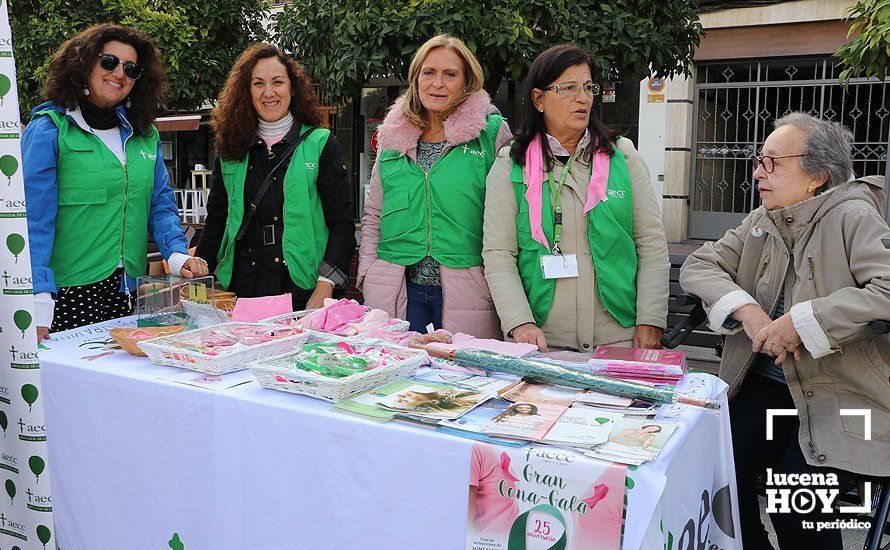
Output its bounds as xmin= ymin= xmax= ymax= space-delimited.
xmin=216 ymin=125 xmax=331 ymax=290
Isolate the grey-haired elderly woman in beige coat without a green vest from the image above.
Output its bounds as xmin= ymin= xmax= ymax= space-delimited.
xmin=680 ymin=113 xmax=890 ymax=550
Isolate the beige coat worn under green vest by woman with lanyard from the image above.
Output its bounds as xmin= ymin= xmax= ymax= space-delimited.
xmin=482 ymin=137 xmax=670 ymax=351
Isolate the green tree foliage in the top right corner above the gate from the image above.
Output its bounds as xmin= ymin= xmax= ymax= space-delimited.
xmin=835 ymin=0 xmax=890 ymax=82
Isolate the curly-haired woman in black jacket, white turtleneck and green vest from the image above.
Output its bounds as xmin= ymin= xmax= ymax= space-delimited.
xmin=198 ymin=44 xmax=355 ymax=310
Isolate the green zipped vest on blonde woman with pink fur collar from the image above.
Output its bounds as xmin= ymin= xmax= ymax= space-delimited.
xmin=377 ymin=115 xmax=504 ymax=268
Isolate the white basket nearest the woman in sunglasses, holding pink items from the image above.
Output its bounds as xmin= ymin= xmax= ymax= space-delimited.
xmin=138 ymin=323 xmax=309 ymax=374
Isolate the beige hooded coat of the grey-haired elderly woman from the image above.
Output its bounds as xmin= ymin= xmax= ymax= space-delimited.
xmin=680 ymin=177 xmax=890 ymax=476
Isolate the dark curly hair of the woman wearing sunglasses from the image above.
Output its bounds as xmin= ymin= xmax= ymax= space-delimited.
xmin=43 ymin=23 xmax=167 ymax=136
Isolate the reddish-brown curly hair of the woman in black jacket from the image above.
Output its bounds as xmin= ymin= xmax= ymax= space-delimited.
xmin=210 ymin=43 xmax=323 ymax=160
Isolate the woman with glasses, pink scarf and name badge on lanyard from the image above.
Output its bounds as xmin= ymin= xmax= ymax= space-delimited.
xmin=482 ymin=46 xmax=670 ymax=351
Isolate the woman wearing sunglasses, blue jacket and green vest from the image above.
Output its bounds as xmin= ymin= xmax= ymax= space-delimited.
xmin=22 ymin=24 xmax=208 ymax=340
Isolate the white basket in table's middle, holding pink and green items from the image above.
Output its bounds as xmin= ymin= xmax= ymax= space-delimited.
xmin=248 ymin=339 xmax=426 ymax=403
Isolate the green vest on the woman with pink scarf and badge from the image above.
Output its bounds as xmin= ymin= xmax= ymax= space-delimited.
xmin=510 ymin=150 xmax=637 ymax=327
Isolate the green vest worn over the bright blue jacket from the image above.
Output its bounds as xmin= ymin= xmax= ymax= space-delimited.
xmin=36 ymin=109 xmax=158 ymax=288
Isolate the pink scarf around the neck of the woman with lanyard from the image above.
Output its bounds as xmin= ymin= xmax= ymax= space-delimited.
xmin=523 ymin=134 xmax=609 ymax=249
